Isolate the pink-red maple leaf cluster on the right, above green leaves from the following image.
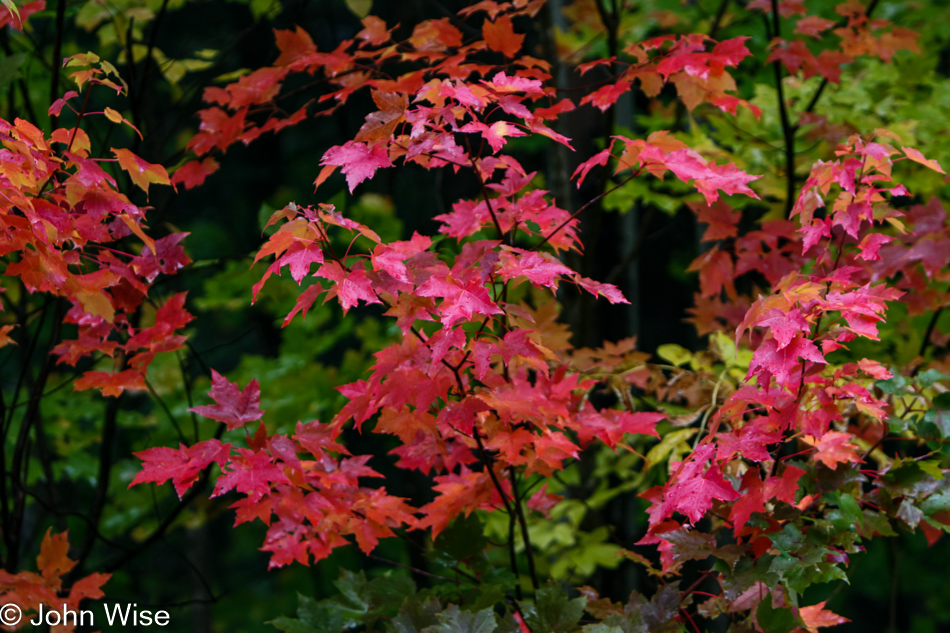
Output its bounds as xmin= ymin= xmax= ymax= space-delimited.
xmin=628 ymin=130 xmax=950 ymax=617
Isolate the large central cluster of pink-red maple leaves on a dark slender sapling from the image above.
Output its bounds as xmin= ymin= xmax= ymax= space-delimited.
xmin=133 ymin=3 xmax=708 ymax=565
